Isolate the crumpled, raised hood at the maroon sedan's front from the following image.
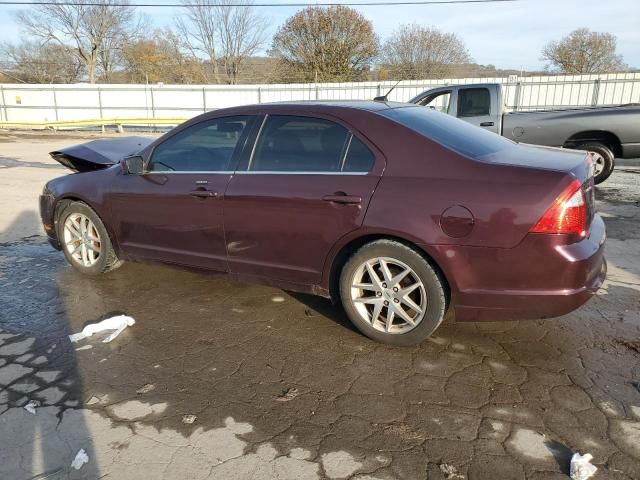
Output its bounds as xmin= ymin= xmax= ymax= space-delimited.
xmin=49 ymin=137 xmax=154 ymax=172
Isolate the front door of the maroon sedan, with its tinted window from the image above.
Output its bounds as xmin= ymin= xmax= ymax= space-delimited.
xmin=110 ymin=116 xmax=251 ymax=271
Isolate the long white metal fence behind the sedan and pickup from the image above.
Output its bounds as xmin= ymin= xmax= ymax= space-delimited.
xmin=0 ymin=73 xmax=640 ymax=126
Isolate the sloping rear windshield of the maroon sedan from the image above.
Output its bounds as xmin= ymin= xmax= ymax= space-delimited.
xmin=380 ymin=106 xmax=515 ymax=158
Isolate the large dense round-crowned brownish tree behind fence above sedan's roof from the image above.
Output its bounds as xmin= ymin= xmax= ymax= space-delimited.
xmin=271 ymin=6 xmax=379 ymax=81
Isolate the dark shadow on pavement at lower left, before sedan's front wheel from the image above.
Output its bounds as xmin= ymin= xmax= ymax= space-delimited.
xmin=0 ymin=212 xmax=100 ymax=480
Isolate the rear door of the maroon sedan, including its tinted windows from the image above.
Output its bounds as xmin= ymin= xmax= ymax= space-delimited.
xmin=224 ymin=115 xmax=384 ymax=284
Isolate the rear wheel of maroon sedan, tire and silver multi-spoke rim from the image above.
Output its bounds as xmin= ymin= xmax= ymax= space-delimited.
xmin=340 ymin=240 xmax=447 ymax=346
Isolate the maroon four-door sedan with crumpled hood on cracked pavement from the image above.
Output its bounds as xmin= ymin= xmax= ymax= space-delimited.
xmin=41 ymin=102 xmax=606 ymax=345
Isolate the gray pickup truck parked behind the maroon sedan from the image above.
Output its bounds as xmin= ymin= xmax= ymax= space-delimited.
xmin=410 ymin=83 xmax=640 ymax=183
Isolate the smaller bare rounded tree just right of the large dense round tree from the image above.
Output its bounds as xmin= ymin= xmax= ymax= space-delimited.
xmin=382 ymin=24 xmax=471 ymax=79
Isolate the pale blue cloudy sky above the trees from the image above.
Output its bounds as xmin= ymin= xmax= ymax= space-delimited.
xmin=0 ymin=0 xmax=640 ymax=70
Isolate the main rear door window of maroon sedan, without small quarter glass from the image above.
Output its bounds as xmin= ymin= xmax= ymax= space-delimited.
xmin=249 ymin=115 xmax=349 ymax=172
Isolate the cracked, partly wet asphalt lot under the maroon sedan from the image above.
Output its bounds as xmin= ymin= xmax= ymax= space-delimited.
xmin=0 ymin=133 xmax=640 ymax=480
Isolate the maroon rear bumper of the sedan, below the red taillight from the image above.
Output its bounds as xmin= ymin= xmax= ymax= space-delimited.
xmin=428 ymin=215 xmax=607 ymax=322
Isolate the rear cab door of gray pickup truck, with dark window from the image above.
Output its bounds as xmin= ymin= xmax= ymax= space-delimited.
xmin=455 ymin=87 xmax=502 ymax=133
